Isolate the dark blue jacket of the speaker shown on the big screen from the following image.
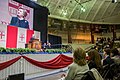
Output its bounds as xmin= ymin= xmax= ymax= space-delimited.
xmin=10 ymin=17 xmax=29 ymax=29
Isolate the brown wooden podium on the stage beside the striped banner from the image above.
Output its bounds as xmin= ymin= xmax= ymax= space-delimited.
xmin=27 ymin=39 xmax=41 ymax=50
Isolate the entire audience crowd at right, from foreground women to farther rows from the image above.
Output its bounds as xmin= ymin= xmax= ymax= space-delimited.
xmin=58 ymin=38 xmax=120 ymax=80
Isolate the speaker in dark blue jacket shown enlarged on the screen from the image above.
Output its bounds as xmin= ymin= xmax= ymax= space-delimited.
xmin=10 ymin=8 xmax=29 ymax=29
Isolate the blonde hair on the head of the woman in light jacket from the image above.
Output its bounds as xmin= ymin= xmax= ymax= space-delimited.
xmin=73 ymin=48 xmax=86 ymax=66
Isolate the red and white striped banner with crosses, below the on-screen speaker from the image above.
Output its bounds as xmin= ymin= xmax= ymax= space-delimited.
xmin=0 ymin=25 xmax=40 ymax=48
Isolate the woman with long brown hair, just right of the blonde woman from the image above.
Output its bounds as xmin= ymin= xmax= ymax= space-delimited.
xmin=88 ymin=49 xmax=101 ymax=71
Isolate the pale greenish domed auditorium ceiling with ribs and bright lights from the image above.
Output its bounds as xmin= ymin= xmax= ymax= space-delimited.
xmin=37 ymin=0 xmax=120 ymax=24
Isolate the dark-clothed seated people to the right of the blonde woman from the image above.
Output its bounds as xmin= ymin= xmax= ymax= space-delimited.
xmin=88 ymin=48 xmax=120 ymax=80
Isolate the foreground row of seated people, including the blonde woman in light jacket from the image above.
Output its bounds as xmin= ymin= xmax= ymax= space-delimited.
xmin=60 ymin=48 xmax=120 ymax=80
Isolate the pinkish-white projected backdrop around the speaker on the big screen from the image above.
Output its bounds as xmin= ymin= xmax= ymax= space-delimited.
xmin=0 ymin=0 xmax=33 ymax=30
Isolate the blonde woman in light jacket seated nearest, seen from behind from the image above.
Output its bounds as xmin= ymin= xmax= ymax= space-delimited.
xmin=64 ymin=48 xmax=89 ymax=80
